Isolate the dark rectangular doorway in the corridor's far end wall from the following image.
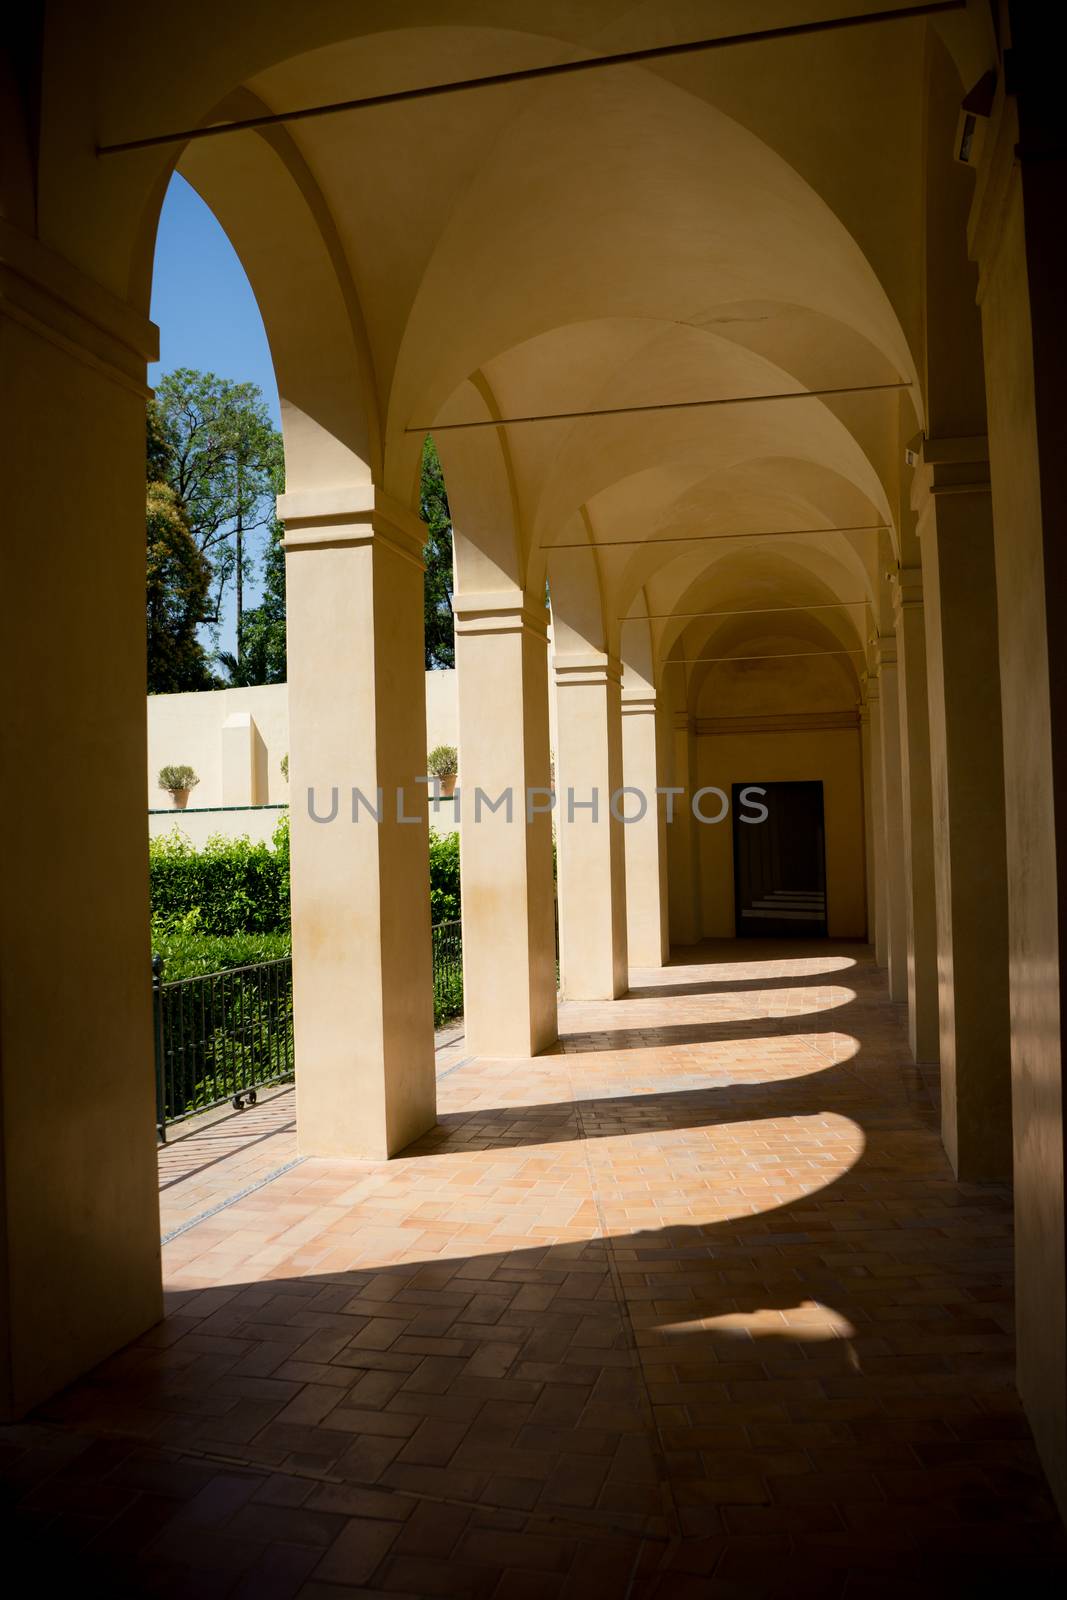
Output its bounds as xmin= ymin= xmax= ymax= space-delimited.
xmin=731 ymin=782 xmax=825 ymax=939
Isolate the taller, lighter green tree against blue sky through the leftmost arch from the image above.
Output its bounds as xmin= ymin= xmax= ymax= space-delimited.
xmin=155 ymin=366 xmax=282 ymax=661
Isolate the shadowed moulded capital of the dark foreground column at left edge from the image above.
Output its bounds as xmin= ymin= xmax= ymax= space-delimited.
xmin=0 ymin=219 xmax=160 ymax=400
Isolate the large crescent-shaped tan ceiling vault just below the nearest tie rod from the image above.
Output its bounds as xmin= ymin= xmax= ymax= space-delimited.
xmin=390 ymin=29 xmax=913 ymax=438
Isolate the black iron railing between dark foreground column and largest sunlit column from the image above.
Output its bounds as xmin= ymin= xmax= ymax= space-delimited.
xmin=152 ymin=955 xmax=294 ymax=1141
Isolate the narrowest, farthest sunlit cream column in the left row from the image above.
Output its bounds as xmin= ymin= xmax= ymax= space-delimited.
xmin=622 ymin=686 xmax=670 ymax=966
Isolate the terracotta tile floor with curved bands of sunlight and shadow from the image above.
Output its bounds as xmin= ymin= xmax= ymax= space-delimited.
xmin=0 ymin=942 xmax=1067 ymax=1600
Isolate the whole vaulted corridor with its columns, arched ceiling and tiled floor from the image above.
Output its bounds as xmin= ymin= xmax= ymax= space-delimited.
xmin=0 ymin=0 xmax=1067 ymax=1574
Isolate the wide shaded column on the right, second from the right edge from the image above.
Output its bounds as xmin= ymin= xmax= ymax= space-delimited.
xmin=912 ymin=438 xmax=1011 ymax=1182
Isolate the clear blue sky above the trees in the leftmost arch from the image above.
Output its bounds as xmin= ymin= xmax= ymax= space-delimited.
xmin=149 ymin=174 xmax=280 ymax=650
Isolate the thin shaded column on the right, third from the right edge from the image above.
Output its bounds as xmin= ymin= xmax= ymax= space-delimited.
xmin=893 ymin=566 xmax=939 ymax=1061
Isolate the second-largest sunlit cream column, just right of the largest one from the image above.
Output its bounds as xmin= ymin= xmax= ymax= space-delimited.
xmin=453 ymin=590 xmax=557 ymax=1058
